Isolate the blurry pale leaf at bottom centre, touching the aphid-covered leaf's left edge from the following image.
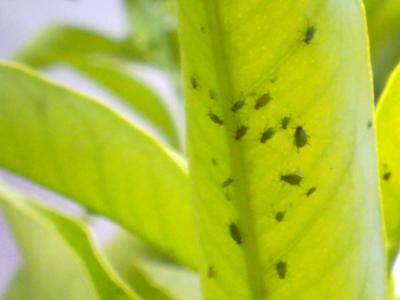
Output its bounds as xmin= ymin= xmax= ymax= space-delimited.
xmin=105 ymin=233 xmax=202 ymax=300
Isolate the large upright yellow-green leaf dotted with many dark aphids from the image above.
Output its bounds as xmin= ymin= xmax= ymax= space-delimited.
xmin=179 ymin=0 xmax=386 ymax=300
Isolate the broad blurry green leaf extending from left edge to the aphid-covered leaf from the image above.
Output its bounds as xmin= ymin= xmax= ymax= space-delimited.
xmin=0 ymin=63 xmax=197 ymax=267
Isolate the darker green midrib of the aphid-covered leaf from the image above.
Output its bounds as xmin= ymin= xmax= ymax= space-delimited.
xmin=204 ymin=0 xmax=263 ymax=299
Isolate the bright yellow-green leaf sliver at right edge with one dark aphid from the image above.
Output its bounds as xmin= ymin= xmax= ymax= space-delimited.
xmin=376 ymin=62 xmax=400 ymax=267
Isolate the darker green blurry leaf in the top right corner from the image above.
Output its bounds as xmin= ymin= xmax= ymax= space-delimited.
xmin=364 ymin=0 xmax=400 ymax=95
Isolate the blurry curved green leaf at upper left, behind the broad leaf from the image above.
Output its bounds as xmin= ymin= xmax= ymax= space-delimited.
xmin=16 ymin=26 xmax=178 ymax=147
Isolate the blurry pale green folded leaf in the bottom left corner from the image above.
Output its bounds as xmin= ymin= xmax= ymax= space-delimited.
xmin=0 ymin=186 xmax=139 ymax=300
